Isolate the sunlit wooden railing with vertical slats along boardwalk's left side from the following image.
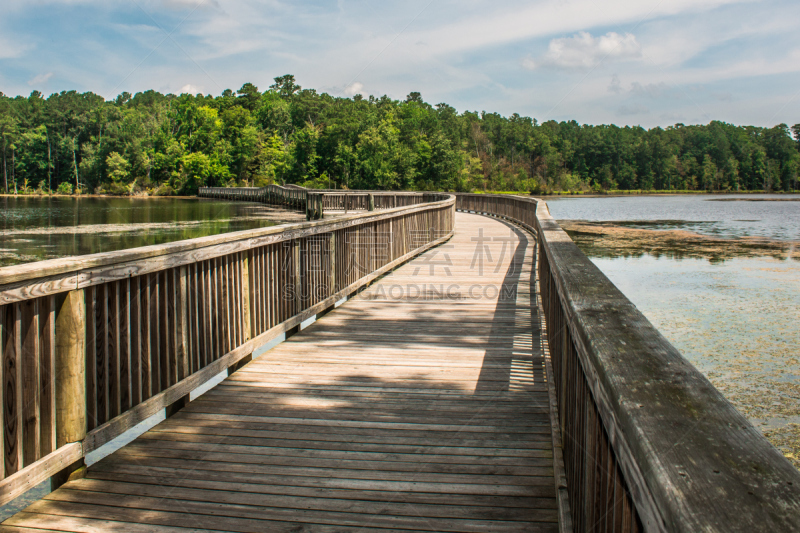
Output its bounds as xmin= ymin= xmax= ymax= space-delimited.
xmin=0 ymin=189 xmax=455 ymax=504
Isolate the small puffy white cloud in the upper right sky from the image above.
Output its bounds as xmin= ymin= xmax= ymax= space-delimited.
xmin=524 ymin=31 xmax=642 ymax=69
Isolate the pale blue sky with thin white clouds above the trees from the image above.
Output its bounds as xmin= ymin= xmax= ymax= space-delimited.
xmin=0 ymin=0 xmax=800 ymax=128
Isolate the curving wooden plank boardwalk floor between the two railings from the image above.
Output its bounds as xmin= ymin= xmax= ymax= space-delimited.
xmin=0 ymin=213 xmax=558 ymax=533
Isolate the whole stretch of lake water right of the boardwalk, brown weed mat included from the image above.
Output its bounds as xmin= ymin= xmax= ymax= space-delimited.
xmin=547 ymin=195 xmax=800 ymax=467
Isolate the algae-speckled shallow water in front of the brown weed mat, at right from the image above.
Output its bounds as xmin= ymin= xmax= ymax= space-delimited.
xmin=592 ymin=251 xmax=800 ymax=468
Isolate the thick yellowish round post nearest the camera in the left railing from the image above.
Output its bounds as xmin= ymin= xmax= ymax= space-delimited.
xmin=50 ymin=289 xmax=87 ymax=490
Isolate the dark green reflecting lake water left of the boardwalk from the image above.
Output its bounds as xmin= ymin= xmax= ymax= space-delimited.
xmin=0 ymin=196 xmax=302 ymax=267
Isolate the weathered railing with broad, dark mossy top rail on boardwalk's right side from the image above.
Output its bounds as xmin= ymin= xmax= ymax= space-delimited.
xmin=456 ymin=195 xmax=800 ymax=532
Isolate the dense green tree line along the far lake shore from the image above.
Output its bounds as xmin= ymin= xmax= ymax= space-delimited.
xmin=0 ymin=75 xmax=800 ymax=194
